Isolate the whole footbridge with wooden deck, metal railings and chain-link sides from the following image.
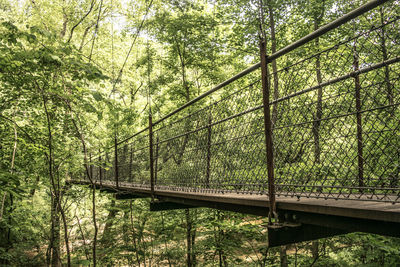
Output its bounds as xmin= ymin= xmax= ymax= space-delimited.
xmin=69 ymin=1 xmax=400 ymax=246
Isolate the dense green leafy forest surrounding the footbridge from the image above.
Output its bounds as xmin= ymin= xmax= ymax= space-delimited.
xmin=0 ymin=0 xmax=400 ymax=266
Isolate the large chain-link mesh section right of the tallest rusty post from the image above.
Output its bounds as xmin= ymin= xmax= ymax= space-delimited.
xmin=272 ymin=3 xmax=400 ymax=202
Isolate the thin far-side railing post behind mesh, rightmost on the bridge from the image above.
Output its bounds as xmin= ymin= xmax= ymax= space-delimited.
xmin=353 ymin=44 xmax=364 ymax=189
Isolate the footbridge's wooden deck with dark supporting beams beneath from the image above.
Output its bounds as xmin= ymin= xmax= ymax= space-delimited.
xmin=70 ymin=181 xmax=400 ymax=247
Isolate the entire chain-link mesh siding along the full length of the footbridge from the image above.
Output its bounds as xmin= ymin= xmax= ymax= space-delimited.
xmin=84 ymin=2 xmax=400 ymax=202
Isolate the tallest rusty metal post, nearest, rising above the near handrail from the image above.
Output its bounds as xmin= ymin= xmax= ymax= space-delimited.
xmin=260 ymin=39 xmax=277 ymax=224
